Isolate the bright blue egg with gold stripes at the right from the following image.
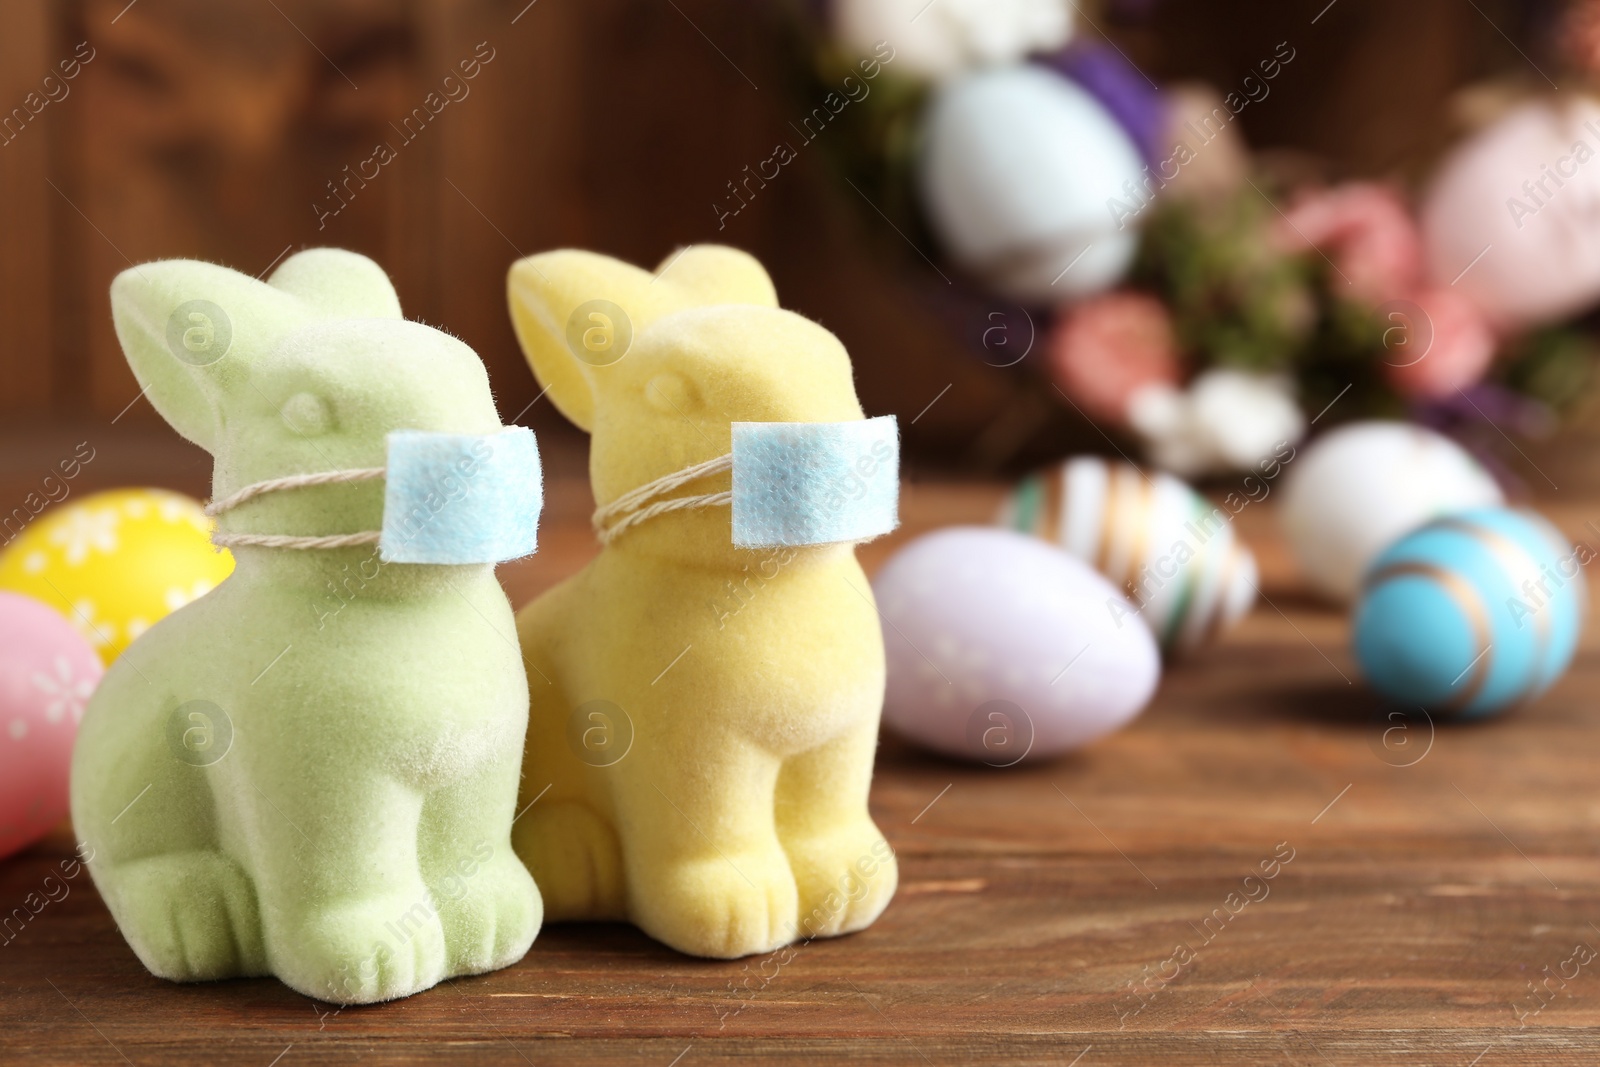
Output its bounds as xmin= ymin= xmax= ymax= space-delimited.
xmin=1354 ymin=507 xmax=1595 ymax=718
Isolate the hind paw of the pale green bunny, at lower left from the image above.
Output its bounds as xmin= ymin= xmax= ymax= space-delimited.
xmin=99 ymin=851 xmax=267 ymax=982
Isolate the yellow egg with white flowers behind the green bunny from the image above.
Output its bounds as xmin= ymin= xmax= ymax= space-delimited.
xmin=0 ymin=490 xmax=234 ymax=664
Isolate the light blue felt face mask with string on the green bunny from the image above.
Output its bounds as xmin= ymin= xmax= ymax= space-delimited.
xmin=206 ymin=426 xmax=544 ymax=563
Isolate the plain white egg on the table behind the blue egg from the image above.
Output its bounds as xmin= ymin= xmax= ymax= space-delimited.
xmin=1278 ymin=421 xmax=1506 ymax=601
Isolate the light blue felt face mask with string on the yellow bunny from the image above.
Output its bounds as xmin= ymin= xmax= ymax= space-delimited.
xmin=594 ymin=414 xmax=899 ymax=549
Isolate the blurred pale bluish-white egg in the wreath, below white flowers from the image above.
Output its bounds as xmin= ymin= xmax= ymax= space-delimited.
xmin=920 ymin=66 xmax=1144 ymax=304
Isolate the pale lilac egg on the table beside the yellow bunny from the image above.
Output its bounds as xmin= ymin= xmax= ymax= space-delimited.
xmin=872 ymin=526 xmax=1162 ymax=766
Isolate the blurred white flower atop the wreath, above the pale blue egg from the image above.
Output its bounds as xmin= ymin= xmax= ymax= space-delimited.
xmin=834 ymin=0 xmax=1074 ymax=80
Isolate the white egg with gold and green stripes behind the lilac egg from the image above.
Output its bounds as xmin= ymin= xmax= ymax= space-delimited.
xmin=1000 ymin=456 xmax=1256 ymax=653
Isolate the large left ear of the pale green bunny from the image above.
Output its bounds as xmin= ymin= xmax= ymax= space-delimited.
xmin=110 ymin=259 xmax=310 ymax=451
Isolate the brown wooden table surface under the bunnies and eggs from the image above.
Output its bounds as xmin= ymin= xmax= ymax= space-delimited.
xmin=0 ymin=454 xmax=1600 ymax=1067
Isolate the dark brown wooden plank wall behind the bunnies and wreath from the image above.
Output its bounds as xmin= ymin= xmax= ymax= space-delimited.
xmin=0 ymin=0 xmax=1547 ymax=470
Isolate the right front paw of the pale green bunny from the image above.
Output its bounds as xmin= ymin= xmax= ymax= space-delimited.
xmin=432 ymin=849 xmax=544 ymax=974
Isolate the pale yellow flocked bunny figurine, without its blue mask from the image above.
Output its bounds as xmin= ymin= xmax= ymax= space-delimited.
xmin=509 ymin=246 xmax=896 ymax=958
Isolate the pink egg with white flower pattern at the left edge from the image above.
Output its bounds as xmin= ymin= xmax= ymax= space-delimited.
xmin=0 ymin=592 xmax=104 ymax=857
